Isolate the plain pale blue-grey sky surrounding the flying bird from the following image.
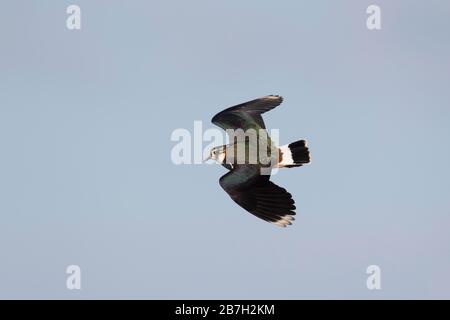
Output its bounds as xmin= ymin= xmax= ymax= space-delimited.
xmin=0 ymin=0 xmax=450 ymax=299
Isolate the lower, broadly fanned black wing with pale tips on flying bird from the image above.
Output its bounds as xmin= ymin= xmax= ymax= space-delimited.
xmin=219 ymin=165 xmax=295 ymax=227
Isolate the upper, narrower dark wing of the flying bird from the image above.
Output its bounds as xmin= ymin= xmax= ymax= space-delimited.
xmin=211 ymin=96 xmax=283 ymax=131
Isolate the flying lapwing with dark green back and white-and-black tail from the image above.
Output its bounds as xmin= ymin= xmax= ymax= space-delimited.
xmin=205 ymin=95 xmax=311 ymax=227
